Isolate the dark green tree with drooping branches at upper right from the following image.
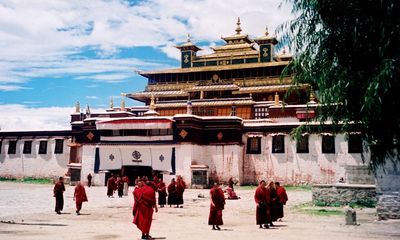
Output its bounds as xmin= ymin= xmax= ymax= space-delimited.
xmin=279 ymin=0 xmax=400 ymax=169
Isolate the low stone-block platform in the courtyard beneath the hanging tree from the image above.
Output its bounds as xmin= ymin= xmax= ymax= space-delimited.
xmin=312 ymin=184 xmax=377 ymax=205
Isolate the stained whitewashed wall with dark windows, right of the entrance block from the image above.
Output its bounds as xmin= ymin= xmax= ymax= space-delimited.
xmin=241 ymin=134 xmax=368 ymax=184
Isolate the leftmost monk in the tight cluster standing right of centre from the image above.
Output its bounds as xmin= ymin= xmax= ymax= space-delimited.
xmin=254 ymin=180 xmax=271 ymax=228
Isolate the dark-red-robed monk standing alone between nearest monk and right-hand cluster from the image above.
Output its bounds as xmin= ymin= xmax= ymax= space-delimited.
xmin=208 ymin=182 xmax=225 ymax=230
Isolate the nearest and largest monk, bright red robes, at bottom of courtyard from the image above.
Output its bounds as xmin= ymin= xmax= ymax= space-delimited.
xmin=132 ymin=180 xmax=158 ymax=239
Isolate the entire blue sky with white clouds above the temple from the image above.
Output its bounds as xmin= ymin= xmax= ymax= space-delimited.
xmin=0 ymin=0 xmax=292 ymax=131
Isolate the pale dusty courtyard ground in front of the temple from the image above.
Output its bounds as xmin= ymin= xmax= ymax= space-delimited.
xmin=0 ymin=182 xmax=400 ymax=240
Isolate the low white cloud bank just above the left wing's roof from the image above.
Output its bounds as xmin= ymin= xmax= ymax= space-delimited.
xmin=0 ymin=104 xmax=104 ymax=131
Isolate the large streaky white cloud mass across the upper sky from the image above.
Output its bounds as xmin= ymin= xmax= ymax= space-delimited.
xmin=0 ymin=0 xmax=290 ymax=91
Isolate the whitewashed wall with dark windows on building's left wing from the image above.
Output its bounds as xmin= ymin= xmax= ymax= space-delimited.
xmin=0 ymin=138 xmax=70 ymax=178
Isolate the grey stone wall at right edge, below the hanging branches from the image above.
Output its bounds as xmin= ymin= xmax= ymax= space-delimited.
xmin=376 ymin=159 xmax=400 ymax=220
